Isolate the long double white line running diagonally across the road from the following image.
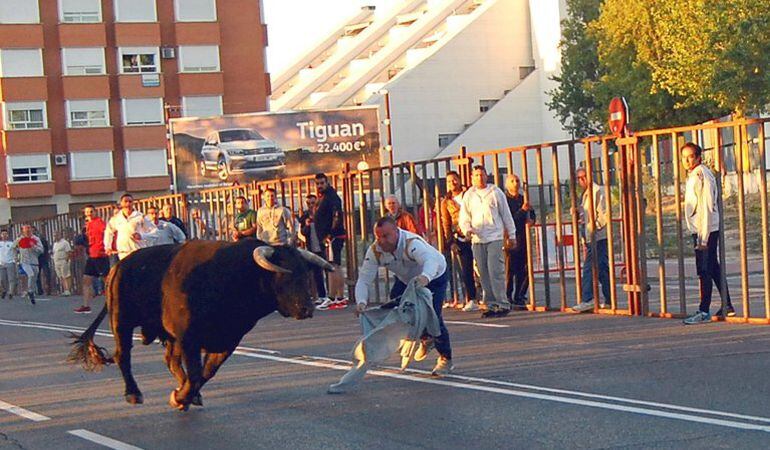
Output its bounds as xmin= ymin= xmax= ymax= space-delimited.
xmin=0 ymin=319 xmax=770 ymax=434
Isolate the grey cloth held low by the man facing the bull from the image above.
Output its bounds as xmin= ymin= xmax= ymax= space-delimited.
xmin=327 ymin=281 xmax=441 ymax=394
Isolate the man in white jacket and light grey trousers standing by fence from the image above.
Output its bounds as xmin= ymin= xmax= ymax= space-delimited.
xmin=459 ymin=166 xmax=516 ymax=316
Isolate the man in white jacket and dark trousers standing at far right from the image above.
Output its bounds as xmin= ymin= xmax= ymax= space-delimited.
xmin=681 ymin=142 xmax=735 ymax=325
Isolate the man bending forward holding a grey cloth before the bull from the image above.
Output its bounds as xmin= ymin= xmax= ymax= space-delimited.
xmin=355 ymin=217 xmax=454 ymax=375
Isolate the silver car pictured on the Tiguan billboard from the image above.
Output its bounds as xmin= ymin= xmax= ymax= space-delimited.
xmin=199 ymin=128 xmax=286 ymax=181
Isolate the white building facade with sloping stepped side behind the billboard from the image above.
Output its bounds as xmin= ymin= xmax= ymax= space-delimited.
xmin=271 ymin=0 xmax=568 ymax=169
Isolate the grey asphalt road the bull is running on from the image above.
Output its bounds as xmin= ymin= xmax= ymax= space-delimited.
xmin=0 ymin=299 xmax=770 ymax=449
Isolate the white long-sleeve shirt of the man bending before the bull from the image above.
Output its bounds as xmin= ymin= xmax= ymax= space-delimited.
xmin=356 ymin=229 xmax=444 ymax=305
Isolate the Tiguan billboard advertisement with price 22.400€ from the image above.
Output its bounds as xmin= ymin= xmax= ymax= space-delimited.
xmin=171 ymin=106 xmax=380 ymax=192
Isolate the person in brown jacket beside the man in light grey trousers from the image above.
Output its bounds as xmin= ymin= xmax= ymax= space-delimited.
xmin=440 ymin=171 xmax=478 ymax=311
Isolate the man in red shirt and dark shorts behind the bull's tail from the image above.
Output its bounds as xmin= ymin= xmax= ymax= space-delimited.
xmin=75 ymin=205 xmax=110 ymax=314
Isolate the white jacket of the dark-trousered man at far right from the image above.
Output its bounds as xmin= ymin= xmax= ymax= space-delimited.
xmin=684 ymin=164 xmax=719 ymax=245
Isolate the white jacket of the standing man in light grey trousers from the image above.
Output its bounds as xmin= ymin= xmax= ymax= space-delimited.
xmin=459 ymin=184 xmax=516 ymax=244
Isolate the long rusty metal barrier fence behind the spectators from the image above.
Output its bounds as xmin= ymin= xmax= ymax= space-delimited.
xmin=7 ymin=119 xmax=770 ymax=324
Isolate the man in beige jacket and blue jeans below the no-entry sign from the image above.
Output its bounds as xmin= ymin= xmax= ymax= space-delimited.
xmin=572 ymin=168 xmax=610 ymax=312
